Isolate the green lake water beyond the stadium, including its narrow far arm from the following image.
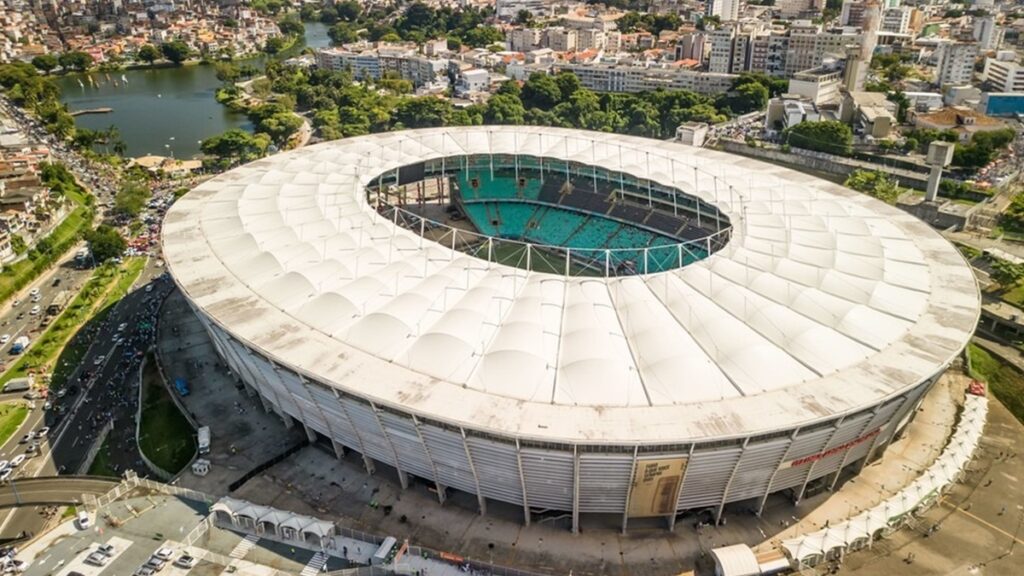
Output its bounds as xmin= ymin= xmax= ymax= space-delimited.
xmin=57 ymin=23 xmax=330 ymax=158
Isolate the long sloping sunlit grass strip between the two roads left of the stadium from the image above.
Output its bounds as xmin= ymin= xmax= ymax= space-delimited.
xmin=0 ymin=258 xmax=145 ymax=387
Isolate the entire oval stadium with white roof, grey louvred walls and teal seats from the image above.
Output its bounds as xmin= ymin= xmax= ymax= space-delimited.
xmin=163 ymin=126 xmax=980 ymax=531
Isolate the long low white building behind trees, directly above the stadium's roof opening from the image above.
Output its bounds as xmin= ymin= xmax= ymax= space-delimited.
xmin=553 ymin=63 xmax=736 ymax=94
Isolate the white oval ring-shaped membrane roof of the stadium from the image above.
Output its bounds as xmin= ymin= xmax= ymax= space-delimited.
xmin=163 ymin=126 xmax=979 ymax=443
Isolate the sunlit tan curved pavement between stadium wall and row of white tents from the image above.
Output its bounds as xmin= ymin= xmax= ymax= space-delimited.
xmin=755 ymin=369 xmax=971 ymax=552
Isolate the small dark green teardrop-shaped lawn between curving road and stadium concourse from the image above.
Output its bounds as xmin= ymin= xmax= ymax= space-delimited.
xmin=138 ymin=355 xmax=196 ymax=474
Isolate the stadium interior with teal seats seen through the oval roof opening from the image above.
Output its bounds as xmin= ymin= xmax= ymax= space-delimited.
xmin=368 ymin=154 xmax=729 ymax=276
